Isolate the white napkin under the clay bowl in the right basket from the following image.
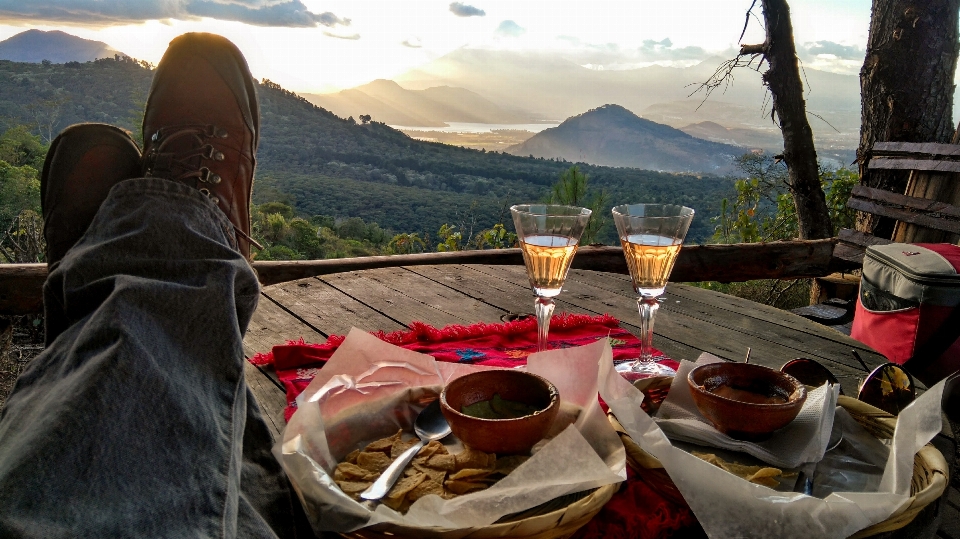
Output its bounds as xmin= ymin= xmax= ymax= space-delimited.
xmin=654 ymin=353 xmax=840 ymax=468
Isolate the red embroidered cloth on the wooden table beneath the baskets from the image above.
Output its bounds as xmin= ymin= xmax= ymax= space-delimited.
xmin=250 ymin=313 xmax=695 ymax=539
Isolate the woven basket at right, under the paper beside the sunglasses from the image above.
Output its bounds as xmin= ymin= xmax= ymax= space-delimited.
xmin=608 ymin=395 xmax=949 ymax=539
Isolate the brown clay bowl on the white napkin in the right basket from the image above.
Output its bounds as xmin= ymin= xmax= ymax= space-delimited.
xmin=687 ymin=363 xmax=807 ymax=441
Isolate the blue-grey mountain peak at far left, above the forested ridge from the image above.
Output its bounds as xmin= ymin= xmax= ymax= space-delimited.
xmin=0 ymin=30 xmax=126 ymax=64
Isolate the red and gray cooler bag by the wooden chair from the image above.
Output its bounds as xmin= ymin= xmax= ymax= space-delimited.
xmin=850 ymin=243 xmax=960 ymax=383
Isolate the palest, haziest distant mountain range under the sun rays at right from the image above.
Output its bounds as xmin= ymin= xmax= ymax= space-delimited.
xmin=394 ymin=48 xmax=860 ymax=147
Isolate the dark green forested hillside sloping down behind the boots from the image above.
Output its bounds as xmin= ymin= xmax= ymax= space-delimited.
xmin=0 ymin=59 xmax=732 ymax=242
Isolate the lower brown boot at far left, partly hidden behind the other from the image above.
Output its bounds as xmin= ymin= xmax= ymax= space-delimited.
xmin=40 ymin=124 xmax=141 ymax=267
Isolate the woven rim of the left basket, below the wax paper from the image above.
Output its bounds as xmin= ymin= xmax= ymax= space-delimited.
xmin=340 ymin=483 xmax=620 ymax=539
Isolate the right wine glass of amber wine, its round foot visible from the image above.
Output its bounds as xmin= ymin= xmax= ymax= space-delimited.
xmin=613 ymin=204 xmax=693 ymax=379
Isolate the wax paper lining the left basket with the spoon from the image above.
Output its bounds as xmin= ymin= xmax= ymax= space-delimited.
xmin=274 ymin=329 xmax=626 ymax=534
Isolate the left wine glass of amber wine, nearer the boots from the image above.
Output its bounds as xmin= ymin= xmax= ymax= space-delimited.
xmin=510 ymin=204 xmax=591 ymax=352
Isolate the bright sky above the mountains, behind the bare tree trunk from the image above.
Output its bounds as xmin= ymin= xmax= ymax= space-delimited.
xmin=0 ymin=0 xmax=871 ymax=93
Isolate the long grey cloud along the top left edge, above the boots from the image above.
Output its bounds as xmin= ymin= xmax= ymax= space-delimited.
xmin=0 ymin=0 xmax=350 ymax=28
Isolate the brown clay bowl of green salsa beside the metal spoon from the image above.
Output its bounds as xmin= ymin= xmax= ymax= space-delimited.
xmin=440 ymin=369 xmax=560 ymax=455
